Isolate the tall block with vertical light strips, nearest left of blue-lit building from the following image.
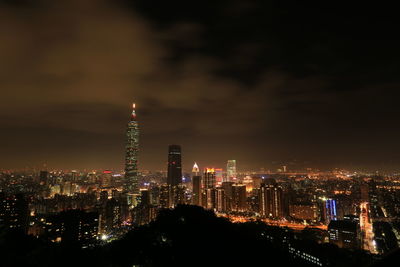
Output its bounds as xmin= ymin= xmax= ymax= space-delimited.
xmin=259 ymin=181 xmax=284 ymax=218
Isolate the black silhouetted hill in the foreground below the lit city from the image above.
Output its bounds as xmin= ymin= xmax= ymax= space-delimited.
xmin=0 ymin=206 xmax=394 ymax=267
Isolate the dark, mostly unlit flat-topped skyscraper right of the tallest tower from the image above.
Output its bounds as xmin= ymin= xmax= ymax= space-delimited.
xmin=167 ymin=145 xmax=182 ymax=186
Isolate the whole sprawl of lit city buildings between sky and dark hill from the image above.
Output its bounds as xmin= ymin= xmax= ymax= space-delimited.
xmin=0 ymin=104 xmax=400 ymax=266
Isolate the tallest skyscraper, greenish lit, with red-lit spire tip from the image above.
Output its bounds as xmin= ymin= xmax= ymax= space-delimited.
xmin=124 ymin=104 xmax=139 ymax=194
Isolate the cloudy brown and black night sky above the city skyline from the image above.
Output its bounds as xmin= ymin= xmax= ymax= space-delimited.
xmin=0 ymin=0 xmax=400 ymax=170
